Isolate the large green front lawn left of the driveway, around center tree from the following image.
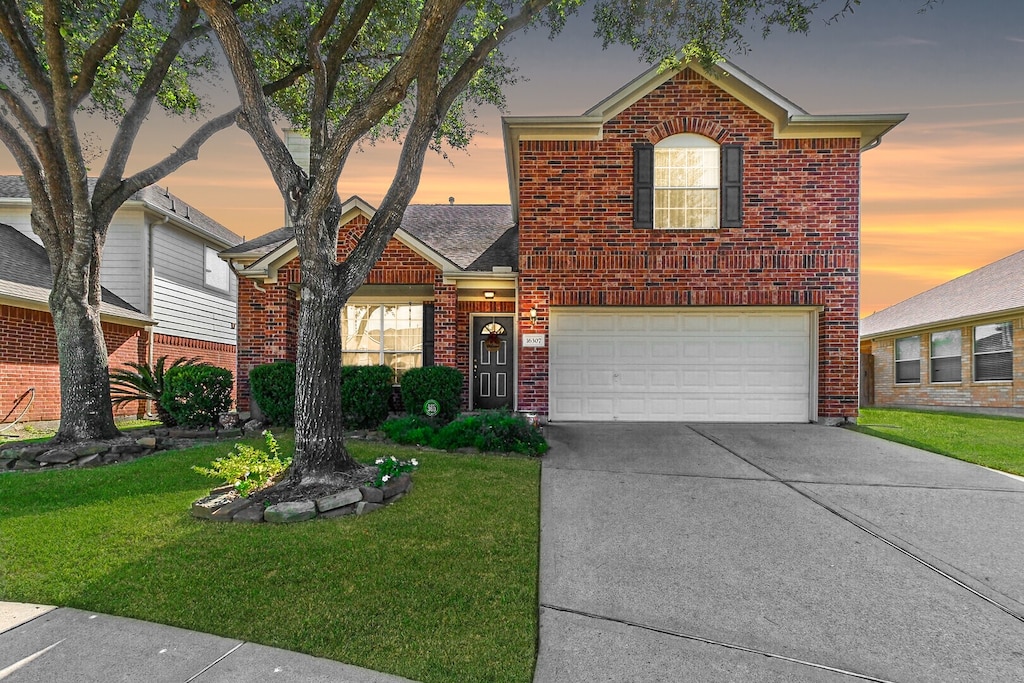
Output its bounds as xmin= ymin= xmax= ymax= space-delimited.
xmin=0 ymin=439 xmax=540 ymax=683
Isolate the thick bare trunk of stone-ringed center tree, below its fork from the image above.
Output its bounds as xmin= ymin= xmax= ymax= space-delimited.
xmin=292 ymin=242 xmax=359 ymax=483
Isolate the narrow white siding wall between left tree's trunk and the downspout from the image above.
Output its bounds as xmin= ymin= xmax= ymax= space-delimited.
xmin=99 ymin=209 xmax=150 ymax=312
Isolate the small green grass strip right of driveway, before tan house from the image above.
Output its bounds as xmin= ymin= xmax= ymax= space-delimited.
xmin=854 ymin=408 xmax=1024 ymax=476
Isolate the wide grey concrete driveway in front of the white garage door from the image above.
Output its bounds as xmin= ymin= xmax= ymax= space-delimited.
xmin=535 ymin=424 xmax=1024 ymax=683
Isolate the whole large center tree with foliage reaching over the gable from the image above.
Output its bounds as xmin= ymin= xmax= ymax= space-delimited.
xmin=196 ymin=0 xmax=872 ymax=484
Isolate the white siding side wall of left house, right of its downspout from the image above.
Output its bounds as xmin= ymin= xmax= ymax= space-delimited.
xmin=153 ymin=220 xmax=238 ymax=344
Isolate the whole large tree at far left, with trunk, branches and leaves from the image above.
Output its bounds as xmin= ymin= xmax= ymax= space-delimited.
xmin=0 ymin=0 xmax=234 ymax=440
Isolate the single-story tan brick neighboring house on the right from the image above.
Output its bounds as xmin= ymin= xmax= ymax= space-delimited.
xmin=860 ymin=251 xmax=1024 ymax=412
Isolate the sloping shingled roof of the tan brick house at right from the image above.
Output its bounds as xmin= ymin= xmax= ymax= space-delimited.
xmin=860 ymin=251 xmax=1024 ymax=337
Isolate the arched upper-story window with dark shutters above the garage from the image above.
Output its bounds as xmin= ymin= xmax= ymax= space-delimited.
xmin=633 ymin=133 xmax=743 ymax=230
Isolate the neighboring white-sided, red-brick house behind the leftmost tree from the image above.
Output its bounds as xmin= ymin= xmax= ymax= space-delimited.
xmin=0 ymin=176 xmax=242 ymax=421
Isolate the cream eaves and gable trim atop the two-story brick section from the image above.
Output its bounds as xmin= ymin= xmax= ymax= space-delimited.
xmin=502 ymin=60 xmax=907 ymax=222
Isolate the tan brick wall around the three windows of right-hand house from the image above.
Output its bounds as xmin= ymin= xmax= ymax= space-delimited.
xmin=869 ymin=317 xmax=1024 ymax=411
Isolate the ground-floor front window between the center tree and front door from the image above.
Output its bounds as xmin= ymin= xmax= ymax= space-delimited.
xmin=341 ymin=304 xmax=423 ymax=381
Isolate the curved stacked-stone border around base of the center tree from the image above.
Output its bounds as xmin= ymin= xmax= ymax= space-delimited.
xmin=191 ymin=472 xmax=413 ymax=524
